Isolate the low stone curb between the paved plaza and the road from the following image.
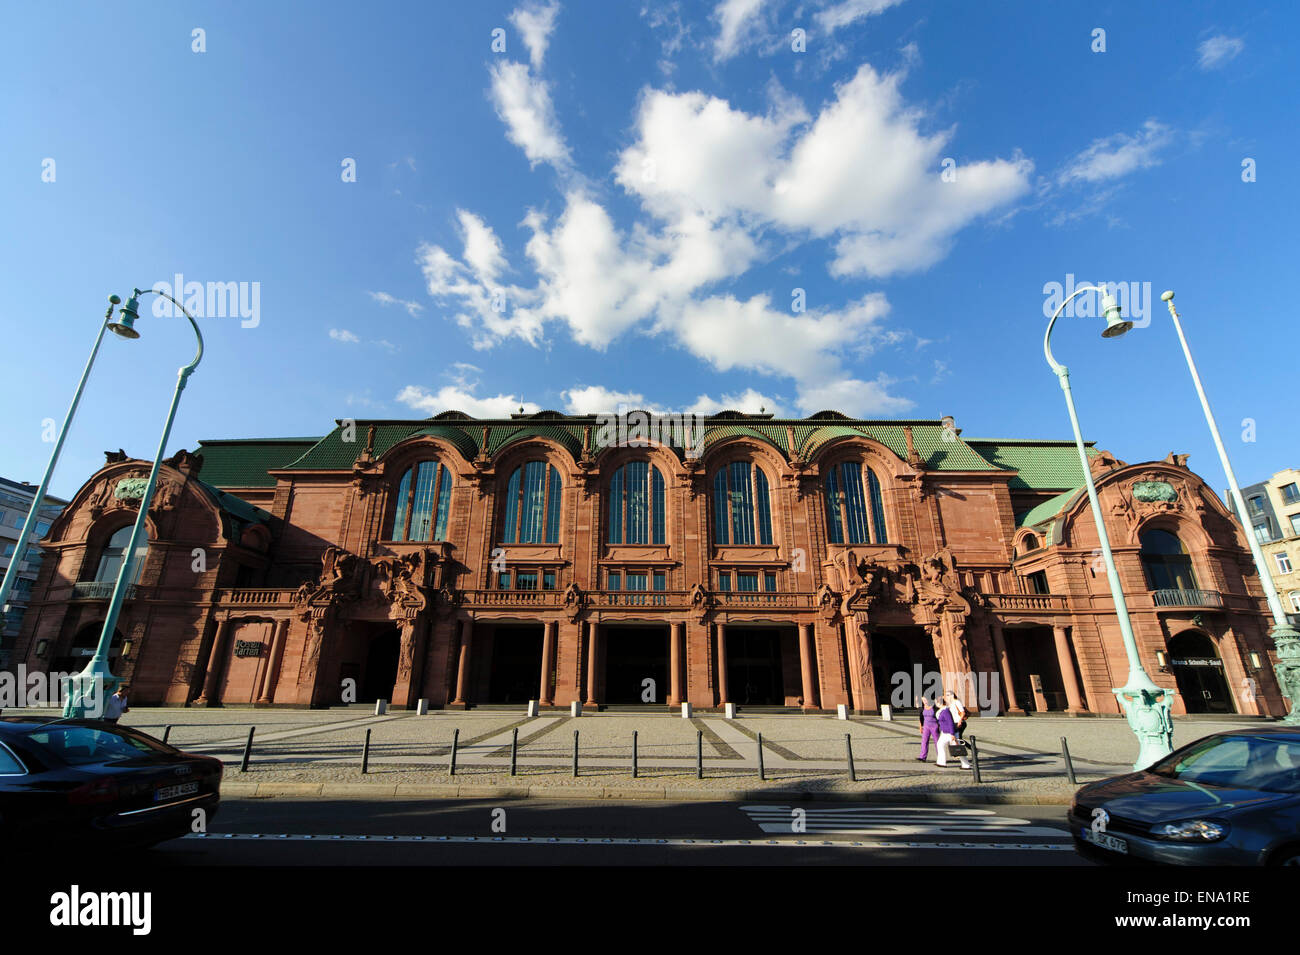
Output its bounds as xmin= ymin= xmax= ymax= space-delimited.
xmin=221 ymin=782 xmax=1070 ymax=806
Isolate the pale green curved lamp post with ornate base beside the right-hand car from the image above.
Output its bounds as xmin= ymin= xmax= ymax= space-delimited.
xmin=1043 ymin=285 xmax=1174 ymax=769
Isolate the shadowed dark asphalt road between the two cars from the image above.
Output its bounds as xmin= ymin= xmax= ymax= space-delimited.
xmin=134 ymin=798 xmax=1087 ymax=867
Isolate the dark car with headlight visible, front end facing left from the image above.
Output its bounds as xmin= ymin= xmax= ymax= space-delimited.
xmin=1069 ymin=728 xmax=1300 ymax=865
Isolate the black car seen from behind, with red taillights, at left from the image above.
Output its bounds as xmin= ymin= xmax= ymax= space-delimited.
xmin=0 ymin=716 xmax=222 ymax=848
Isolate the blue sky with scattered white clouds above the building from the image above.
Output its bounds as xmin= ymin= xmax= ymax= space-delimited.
xmin=0 ymin=0 xmax=1300 ymax=495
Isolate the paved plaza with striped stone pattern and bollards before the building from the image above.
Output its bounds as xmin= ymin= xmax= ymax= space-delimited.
xmin=9 ymin=707 xmax=1269 ymax=803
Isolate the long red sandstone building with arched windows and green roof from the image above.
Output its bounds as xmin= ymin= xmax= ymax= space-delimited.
xmin=14 ymin=412 xmax=1286 ymax=715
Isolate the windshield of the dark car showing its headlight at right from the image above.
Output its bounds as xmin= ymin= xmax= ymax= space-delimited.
xmin=1148 ymin=735 xmax=1300 ymax=793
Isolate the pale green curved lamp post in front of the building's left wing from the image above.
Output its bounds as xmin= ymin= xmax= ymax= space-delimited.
xmin=64 ymin=288 xmax=203 ymax=717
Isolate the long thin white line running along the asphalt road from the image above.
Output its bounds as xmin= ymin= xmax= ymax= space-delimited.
xmin=182 ymin=833 xmax=1074 ymax=852
